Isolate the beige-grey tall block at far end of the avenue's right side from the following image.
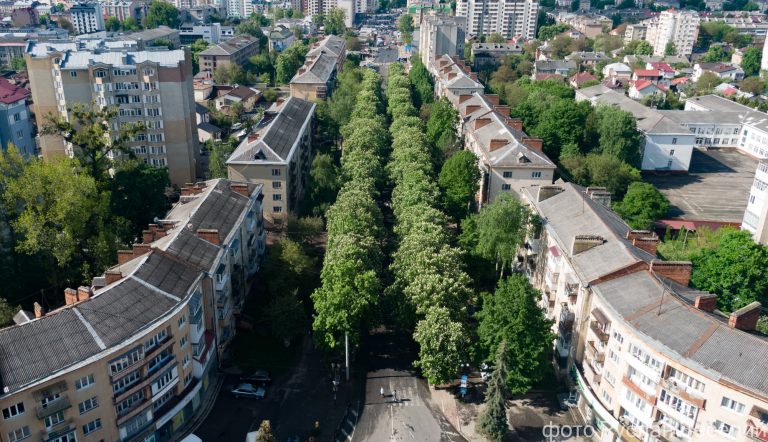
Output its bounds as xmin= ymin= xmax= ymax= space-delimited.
xmin=419 ymin=15 xmax=466 ymax=66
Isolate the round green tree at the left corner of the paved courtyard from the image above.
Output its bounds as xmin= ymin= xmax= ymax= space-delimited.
xmin=613 ymin=181 xmax=669 ymax=230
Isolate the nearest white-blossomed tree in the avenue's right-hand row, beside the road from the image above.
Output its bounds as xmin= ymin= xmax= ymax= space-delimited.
xmin=413 ymin=307 xmax=468 ymax=385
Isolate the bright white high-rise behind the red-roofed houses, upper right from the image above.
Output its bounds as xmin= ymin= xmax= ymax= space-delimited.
xmin=642 ymin=9 xmax=699 ymax=57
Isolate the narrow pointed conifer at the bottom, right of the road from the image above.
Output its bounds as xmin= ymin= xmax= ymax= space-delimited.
xmin=477 ymin=341 xmax=509 ymax=442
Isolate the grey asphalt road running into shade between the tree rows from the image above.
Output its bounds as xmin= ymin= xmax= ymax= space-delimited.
xmin=352 ymin=330 xmax=464 ymax=442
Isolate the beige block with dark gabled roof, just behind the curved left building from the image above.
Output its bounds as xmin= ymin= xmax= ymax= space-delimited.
xmin=227 ymin=97 xmax=315 ymax=222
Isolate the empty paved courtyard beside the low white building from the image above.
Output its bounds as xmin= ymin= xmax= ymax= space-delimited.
xmin=644 ymin=149 xmax=757 ymax=223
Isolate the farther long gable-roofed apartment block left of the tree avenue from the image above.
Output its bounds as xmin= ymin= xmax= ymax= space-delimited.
xmin=290 ymin=35 xmax=347 ymax=101
